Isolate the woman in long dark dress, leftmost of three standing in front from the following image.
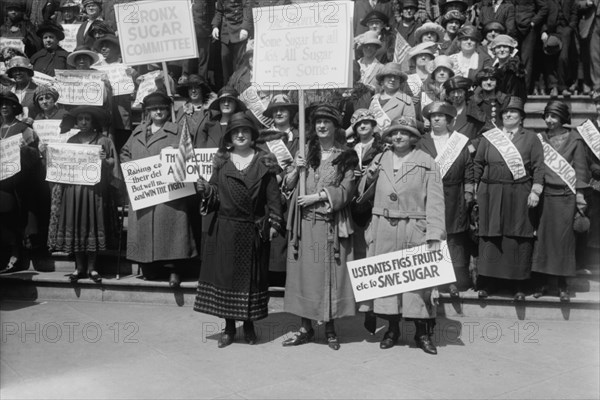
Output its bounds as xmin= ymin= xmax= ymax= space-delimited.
xmin=194 ymin=113 xmax=283 ymax=348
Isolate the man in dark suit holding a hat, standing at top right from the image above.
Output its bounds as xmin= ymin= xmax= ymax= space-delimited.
xmin=542 ymin=0 xmax=577 ymax=97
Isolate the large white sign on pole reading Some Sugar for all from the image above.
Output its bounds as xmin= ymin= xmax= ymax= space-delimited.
xmin=252 ymin=1 xmax=354 ymax=90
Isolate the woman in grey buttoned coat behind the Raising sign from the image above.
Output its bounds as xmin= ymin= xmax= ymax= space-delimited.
xmin=121 ymin=92 xmax=198 ymax=287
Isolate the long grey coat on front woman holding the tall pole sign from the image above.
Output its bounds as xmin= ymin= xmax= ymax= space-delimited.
xmin=284 ymin=145 xmax=356 ymax=321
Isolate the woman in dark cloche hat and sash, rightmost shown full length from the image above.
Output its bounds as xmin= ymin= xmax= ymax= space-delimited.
xmin=531 ymin=100 xmax=590 ymax=301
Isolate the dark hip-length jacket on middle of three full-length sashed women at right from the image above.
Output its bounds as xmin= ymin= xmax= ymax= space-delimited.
xmin=474 ymin=128 xmax=545 ymax=238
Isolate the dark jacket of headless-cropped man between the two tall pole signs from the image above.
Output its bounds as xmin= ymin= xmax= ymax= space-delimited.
xmin=212 ymin=0 xmax=254 ymax=43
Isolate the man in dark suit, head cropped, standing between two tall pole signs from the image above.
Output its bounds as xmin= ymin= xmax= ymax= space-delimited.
xmin=212 ymin=0 xmax=254 ymax=82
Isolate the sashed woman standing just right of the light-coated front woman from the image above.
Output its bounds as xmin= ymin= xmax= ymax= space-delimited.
xmin=417 ymin=102 xmax=475 ymax=297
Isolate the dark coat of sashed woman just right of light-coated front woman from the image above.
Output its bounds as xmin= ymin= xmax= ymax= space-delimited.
xmin=417 ymin=133 xmax=474 ymax=235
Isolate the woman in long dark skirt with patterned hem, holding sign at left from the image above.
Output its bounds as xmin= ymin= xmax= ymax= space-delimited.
xmin=44 ymin=106 xmax=121 ymax=283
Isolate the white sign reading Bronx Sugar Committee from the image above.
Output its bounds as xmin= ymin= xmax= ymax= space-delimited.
xmin=115 ymin=0 xmax=198 ymax=65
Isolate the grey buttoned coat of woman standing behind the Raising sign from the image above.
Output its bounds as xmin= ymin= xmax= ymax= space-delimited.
xmin=121 ymin=122 xmax=197 ymax=263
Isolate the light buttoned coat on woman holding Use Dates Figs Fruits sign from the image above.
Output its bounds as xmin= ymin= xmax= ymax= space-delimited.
xmin=359 ymin=149 xmax=446 ymax=318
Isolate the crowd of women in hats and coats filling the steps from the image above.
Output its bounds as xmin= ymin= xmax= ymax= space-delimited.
xmin=0 ymin=0 xmax=600 ymax=354
